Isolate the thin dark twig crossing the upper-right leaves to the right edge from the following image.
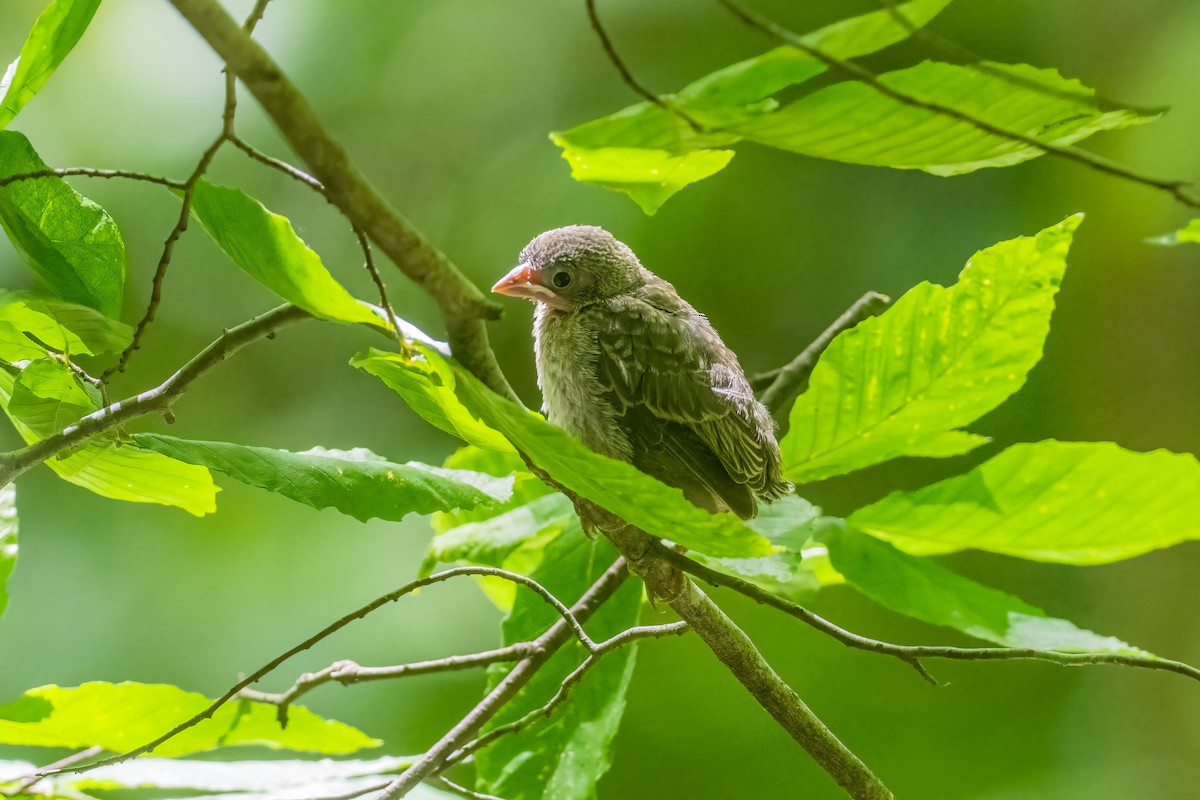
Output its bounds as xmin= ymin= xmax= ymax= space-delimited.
xmin=718 ymin=0 xmax=1200 ymax=209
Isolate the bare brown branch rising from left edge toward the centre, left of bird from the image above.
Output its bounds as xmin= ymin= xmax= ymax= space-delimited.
xmin=0 ymin=305 xmax=310 ymax=486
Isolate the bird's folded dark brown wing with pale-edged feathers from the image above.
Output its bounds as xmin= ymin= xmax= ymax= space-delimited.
xmin=595 ymin=293 xmax=768 ymax=517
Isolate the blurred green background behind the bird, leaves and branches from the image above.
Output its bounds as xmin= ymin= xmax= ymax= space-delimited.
xmin=0 ymin=0 xmax=1200 ymax=800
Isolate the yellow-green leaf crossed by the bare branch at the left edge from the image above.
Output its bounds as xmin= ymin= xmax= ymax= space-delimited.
xmin=0 ymin=361 xmax=217 ymax=517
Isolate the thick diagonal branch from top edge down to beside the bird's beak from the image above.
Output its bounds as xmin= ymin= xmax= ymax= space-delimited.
xmin=163 ymin=0 xmax=516 ymax=398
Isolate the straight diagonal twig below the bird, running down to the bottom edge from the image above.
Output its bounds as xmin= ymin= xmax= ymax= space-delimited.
xmin=378 ymin=558 xmax=629 ymax=800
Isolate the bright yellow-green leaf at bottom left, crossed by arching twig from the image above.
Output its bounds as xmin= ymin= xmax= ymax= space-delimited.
xmin=0 ymin=681 xmax=379 ymax=756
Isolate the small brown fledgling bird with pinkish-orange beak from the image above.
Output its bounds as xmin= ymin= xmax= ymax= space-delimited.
xmin=492 ymin=225 xmax=793 ymax=519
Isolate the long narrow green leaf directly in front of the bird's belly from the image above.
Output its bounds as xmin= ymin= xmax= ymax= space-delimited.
xmin=352 ymin=345 xmax=772 ymax=557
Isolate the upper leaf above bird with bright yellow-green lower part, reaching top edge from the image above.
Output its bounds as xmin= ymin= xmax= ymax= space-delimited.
xmin=551 ymin=0 xmax=950 ymax=213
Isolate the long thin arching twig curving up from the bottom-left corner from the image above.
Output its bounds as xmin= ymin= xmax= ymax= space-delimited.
xmin=38 ymin=566 xmax=599 ymax=777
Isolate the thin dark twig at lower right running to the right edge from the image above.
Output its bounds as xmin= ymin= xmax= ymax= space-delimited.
xmin=660 ymin=547 xmax=1200 ymax=686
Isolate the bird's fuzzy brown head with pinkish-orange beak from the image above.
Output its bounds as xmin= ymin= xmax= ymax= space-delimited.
xmin=492 ymin=225 xmax=646 ymax=311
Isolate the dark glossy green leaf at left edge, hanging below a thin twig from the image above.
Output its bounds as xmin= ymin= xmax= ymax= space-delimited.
xmin=0 ymin=131 xmax=125 ymax=318
